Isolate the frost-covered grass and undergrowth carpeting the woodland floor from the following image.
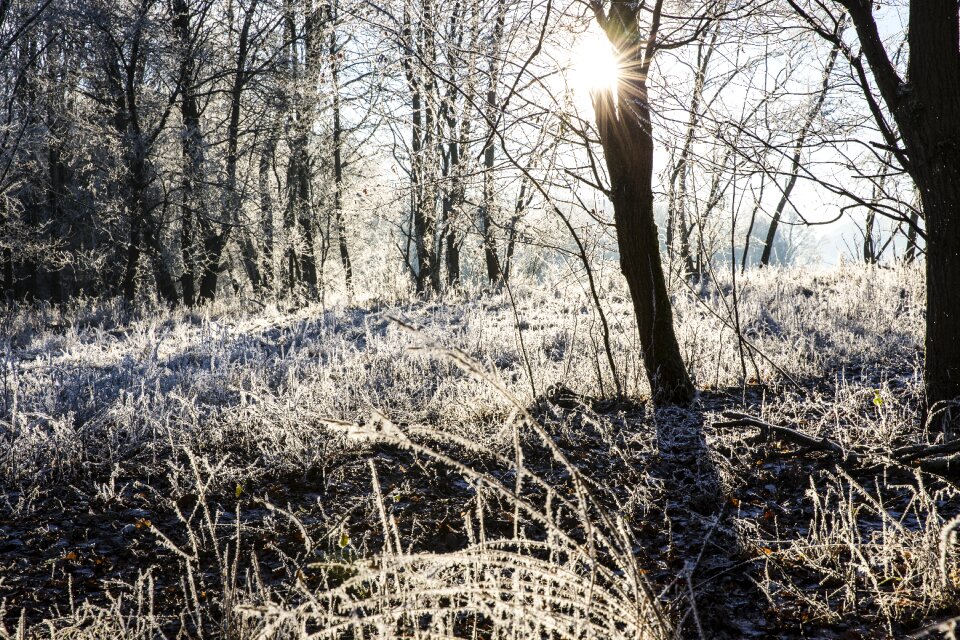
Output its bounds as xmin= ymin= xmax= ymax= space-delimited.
xmin=0 ymin=266 xmax=958 ymax=638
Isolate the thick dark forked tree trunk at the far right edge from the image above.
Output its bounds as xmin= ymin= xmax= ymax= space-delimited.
xmin=839 ymin=0 xmax=960 ymax=424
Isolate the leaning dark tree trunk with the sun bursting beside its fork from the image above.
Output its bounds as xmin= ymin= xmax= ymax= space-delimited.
xmin=594 ymin=0 xmax=694 ymax=403
